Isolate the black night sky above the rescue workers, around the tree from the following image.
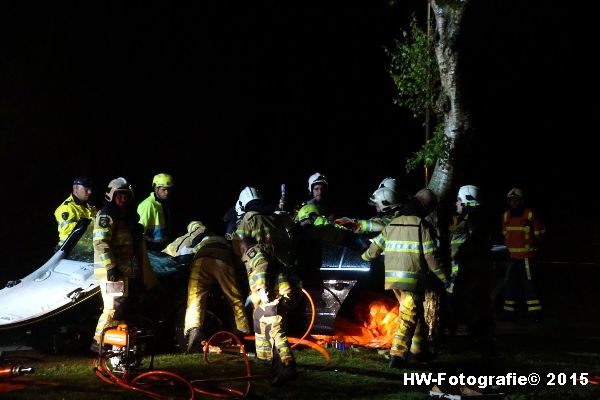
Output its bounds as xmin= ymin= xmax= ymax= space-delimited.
xmin=0 ymin=0 xmax=600 ymax=275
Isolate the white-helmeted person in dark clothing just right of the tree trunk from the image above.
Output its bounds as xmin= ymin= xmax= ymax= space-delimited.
xmin=450 ymin=185 xmax=494 ymax=355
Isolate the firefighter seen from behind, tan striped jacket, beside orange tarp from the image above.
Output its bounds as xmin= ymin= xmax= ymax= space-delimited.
xmin=361 ymin=192 xmax=448 ymax=368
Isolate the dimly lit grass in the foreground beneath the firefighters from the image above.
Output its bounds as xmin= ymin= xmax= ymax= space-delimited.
xmin=0 ymin=324 xmax=600 ymax=400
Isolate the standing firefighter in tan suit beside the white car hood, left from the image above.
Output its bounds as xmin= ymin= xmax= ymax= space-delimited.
xmin=92 ymin=178 xmax=158 ymax=348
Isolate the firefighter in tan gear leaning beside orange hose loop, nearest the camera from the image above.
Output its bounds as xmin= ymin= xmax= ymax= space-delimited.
xmin=240 ymin=237 xmax=301 ymax=385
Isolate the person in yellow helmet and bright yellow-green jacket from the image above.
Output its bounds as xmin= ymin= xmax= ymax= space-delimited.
xmin=137 ymin=173 xmax=175 ymax=251
